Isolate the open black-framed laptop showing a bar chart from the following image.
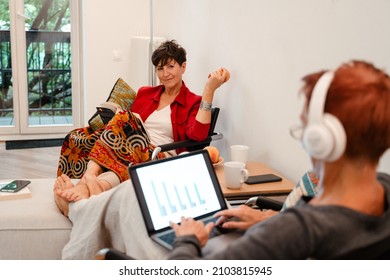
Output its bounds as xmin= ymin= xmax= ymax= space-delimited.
xmin=129 ymin=150 xmax=227 ymax=249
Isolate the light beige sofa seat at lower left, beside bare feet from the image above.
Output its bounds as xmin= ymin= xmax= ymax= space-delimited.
xmin=0 ymin=179 xmax=72 ymax=260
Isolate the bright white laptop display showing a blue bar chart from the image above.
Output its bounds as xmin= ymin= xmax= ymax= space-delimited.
xmin=138 ymin=157 xmax=221 ymax=228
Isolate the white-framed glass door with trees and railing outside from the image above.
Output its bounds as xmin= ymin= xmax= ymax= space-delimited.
xmin=0 ymin=0 xmax=81 ymax=135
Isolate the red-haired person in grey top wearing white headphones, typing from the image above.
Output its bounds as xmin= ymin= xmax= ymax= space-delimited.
xmin=169 ymin=61 xmax=390 ymax=259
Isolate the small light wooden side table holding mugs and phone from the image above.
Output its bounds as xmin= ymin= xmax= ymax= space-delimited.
xmin=215 ymin=161 xmax=295 ymax=200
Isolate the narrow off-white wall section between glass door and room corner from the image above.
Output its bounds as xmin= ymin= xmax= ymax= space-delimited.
xmin=83 ymin=0 xmax=150 ymax=118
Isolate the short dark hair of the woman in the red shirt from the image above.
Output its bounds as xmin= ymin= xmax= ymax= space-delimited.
xmin=152 ymin=40 xmax=187 ymax=66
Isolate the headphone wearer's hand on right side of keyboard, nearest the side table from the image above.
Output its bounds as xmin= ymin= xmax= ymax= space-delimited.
xmin=214 ymin=205 xmax=279 ymax=230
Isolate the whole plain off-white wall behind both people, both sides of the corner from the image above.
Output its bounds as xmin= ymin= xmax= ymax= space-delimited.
xmin=85 ymin=0 xmax=390 ymax=181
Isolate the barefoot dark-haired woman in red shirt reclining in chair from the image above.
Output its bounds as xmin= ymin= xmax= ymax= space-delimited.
xmin=54 ymin=40 xmax=230 ymax=216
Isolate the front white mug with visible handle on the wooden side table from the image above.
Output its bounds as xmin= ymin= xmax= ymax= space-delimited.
xmin=224 ymin=161 xmax=249 ymax=189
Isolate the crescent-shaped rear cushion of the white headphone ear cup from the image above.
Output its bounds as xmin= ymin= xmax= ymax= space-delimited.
xmin=323 ymin=113 xmax=347 ymax=162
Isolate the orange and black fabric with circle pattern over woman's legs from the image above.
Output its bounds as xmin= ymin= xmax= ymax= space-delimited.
xmin=57 ymin=110 xmax=155 ymax=182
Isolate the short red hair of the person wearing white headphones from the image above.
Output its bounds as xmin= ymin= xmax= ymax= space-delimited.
xmin=303 ymin=60 xmax=390 ymax=163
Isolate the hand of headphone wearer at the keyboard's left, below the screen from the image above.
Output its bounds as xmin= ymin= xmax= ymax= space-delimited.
xmin=170 ymin=217 xmax=214 ymax=247
